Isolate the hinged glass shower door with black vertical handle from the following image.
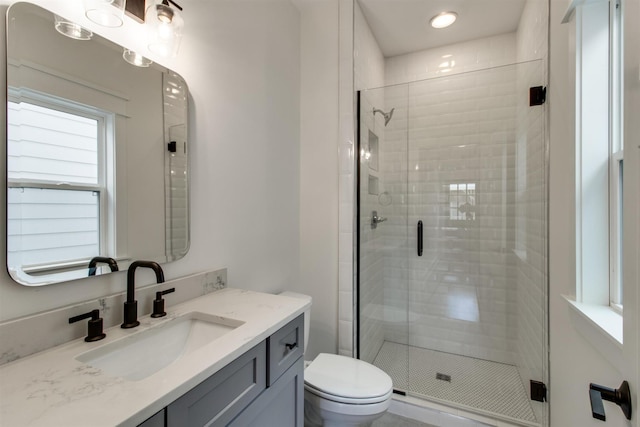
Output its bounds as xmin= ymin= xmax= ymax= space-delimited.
xmin=408 ymin=61 xmax=546 ymax=422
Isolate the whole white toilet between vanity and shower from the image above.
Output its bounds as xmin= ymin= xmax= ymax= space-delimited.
xmin=280 ymin=292 xmax=393 ymax=427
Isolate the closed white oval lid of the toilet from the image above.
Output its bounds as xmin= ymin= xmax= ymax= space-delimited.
xmin=304 ymin=353 xmax=393 ymax=403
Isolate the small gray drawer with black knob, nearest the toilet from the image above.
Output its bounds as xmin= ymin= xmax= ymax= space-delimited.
xmin=267 ymin=314 xmax=304 ymax=386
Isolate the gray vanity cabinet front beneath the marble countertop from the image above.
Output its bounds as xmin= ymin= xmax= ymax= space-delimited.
xmin=139 ymin=315 xmax=304 ymax=427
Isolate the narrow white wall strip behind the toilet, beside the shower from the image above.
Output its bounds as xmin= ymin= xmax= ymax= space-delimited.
xmin=294 ymin=0 xmax=339 ymax=359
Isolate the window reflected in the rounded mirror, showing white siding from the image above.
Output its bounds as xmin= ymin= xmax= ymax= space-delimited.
xmin=7 ymin=94 xmax=114 ymax=274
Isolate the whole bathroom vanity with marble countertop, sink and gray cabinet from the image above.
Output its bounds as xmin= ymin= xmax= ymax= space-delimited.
xmin=0 ymin=289 xmax=308 ymax=427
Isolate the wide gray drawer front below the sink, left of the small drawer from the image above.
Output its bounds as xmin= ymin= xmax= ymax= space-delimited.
xmin=167 ymin=341 xmax=267 ymax=427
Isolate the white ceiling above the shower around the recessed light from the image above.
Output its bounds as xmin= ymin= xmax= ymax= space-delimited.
xmin=358 ymin=0 xmax=525 ymax=57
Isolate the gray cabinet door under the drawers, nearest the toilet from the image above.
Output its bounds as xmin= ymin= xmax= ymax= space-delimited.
xmin=229 ymin=358 xmax=304 ymax=427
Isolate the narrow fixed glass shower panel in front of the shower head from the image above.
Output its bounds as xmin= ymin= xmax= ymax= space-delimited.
xmin=359 ymin=85 xmax=408 ymax=391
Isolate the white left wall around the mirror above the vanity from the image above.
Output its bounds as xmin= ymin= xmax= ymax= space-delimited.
xmin=0 ymin=0 xmax=300 ymax=320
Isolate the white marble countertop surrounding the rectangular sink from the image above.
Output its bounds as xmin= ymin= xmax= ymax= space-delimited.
xmin=0 ymin=289 xmax=308 ymax=427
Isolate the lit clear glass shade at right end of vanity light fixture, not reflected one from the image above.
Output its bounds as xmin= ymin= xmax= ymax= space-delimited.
xmin=145 ymin=1 xmax=184 ymax=56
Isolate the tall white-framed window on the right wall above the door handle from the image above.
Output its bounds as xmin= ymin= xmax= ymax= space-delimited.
xmin=576 ymin=0 xmax=624 ymax=312
